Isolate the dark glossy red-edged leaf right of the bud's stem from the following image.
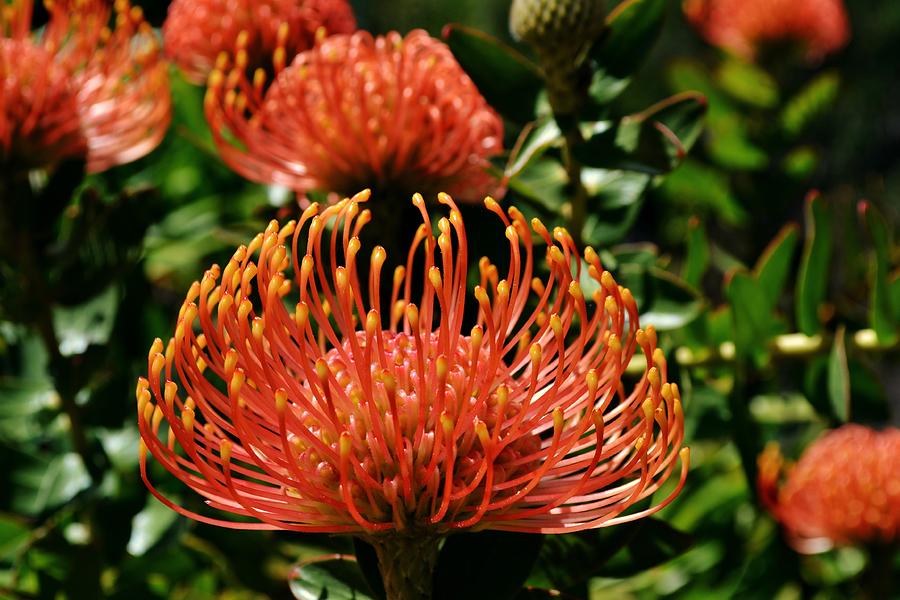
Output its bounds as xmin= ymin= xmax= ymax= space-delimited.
xmin=573 ymin=92 xmax=706 ymax=175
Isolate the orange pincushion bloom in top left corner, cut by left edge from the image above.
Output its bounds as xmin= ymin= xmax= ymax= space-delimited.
xmin=0 ymin=0 xmax=170 ymax=172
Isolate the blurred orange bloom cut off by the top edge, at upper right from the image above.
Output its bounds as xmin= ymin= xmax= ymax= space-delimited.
xmin=684 ymin=0 xmax=850 ymax=60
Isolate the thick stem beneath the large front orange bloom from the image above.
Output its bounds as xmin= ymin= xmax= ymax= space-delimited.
xmin=371 ymin=535 xmax=440 ymax=600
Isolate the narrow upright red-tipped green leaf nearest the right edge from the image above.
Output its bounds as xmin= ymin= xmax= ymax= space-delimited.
xmin=859 ymin=202 xmax=900 ymax=345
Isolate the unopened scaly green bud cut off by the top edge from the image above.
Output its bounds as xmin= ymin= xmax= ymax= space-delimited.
xmin=509 ymin=0 xmax=603 ymax=59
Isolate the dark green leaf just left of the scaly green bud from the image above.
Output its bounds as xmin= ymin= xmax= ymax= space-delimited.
xmin=443 ymin=24 xmax=544 ymax=123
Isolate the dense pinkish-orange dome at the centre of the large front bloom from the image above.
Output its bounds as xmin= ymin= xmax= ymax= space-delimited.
xmin=288 ymin=331 xmax=542 ymax=524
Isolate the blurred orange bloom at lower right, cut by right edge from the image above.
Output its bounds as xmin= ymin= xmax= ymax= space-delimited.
xmin=758 ymin=425 xmax=900 ymax=553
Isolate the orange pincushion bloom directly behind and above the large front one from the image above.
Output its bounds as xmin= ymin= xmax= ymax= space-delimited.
xmin=206 ymin=31 xmax=503 ymax=200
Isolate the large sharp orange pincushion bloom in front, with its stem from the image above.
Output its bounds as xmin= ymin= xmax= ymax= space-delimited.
xmin=137 ymin=193 xmax=688 ymax=598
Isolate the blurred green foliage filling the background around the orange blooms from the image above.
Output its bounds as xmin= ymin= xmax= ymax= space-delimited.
xmin=0 ymin=0 xmax=900 ymax=599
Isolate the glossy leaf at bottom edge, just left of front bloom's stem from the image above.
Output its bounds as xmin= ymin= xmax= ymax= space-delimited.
xmin=288 ymin=554 xmax=373 ymax=600
